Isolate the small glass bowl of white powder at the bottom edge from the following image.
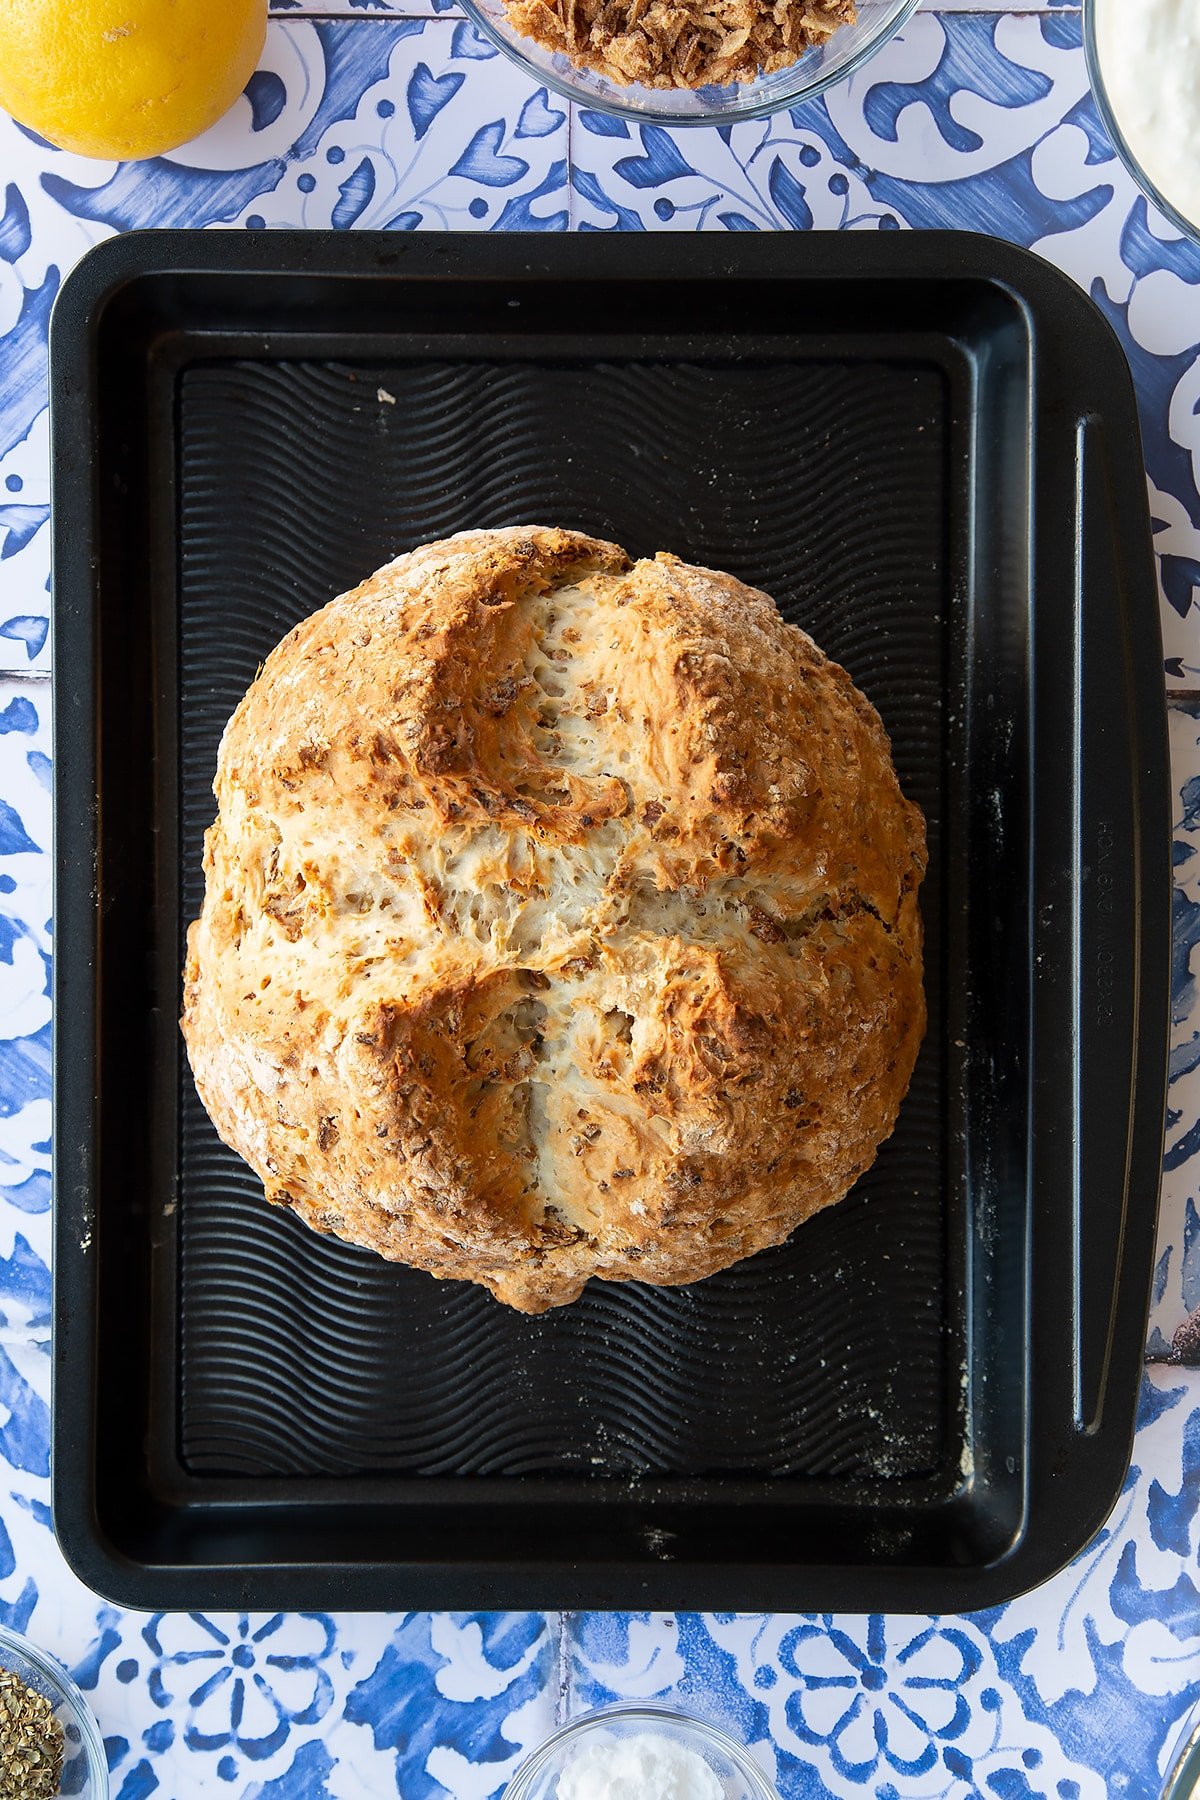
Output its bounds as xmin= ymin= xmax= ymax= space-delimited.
xmin=502 ymin=1703 xmax=779 ymax=1800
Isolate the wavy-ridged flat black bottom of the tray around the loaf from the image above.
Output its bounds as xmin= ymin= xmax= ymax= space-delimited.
xmin=178 ymin=360 xmax=959 ymax=1480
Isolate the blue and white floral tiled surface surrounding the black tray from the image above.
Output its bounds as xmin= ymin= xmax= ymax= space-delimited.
xmin=0 ymin=0 xmax=1200 ymax=1800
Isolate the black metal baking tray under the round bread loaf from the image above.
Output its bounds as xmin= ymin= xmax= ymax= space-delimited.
xmin=50 ymin=232 xmax=1169 ymax=1611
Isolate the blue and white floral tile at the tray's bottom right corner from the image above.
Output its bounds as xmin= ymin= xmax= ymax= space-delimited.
xmin=567 ymin=1370 xmax=1200 ymax=1800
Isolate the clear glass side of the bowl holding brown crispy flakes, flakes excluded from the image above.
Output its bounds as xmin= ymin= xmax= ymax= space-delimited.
xmin=462 ymin=0 xmax=919 ymax=124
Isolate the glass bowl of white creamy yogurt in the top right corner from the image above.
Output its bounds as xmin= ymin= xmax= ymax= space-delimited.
xmin=1083 ymin=0 xmax=1200 ymax=238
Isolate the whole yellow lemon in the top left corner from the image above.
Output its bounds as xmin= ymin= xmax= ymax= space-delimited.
xmin=0 ymin=0 xmax=266 ymax=158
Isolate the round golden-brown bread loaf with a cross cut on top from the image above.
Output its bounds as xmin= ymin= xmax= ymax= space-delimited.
xmin=182 ymin=527 xmax=925 ymax=1312
